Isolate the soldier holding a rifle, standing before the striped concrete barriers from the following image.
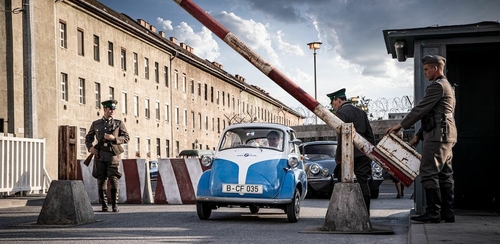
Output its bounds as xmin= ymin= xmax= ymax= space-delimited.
xmin=85 ymin=100 xmax=130 ymax=212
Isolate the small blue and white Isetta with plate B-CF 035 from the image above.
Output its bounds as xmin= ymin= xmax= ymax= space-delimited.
xmin=196 ymin=123 xmax=307 ymax=222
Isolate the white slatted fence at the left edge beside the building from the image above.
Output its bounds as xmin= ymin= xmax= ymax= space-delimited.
xmin=0 ymin=134 xmax=51 ymax=195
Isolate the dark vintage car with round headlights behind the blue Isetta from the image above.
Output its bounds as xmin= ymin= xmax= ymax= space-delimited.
xmin=299 ymin=141 xmax=384 ymax=198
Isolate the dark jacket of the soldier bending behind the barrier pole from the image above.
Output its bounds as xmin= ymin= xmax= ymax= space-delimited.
xmin=335 ymin=102 xmax=375 ymax=162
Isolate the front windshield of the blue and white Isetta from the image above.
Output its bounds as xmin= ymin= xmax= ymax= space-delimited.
xmin=219 ymin=128 xmax=284 ymax=151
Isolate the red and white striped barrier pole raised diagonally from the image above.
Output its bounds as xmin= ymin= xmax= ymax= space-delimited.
xmin=174 ymin=0 xmax=415 ymax=186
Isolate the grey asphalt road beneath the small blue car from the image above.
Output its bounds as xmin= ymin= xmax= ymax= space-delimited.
xmin=0 ymin=180 xmax=413 ymax=243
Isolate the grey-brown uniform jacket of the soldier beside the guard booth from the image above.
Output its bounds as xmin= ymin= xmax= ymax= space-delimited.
xmin=401 ymin=76 xmax=457 ymax=142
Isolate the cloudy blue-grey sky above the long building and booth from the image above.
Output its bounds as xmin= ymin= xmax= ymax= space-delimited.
xmin=100 ymin=0 xmax=500 ymax=120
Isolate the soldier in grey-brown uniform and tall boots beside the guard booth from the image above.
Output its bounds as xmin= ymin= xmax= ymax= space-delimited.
xmin=386 ymin=55 xmax=457 ymax=223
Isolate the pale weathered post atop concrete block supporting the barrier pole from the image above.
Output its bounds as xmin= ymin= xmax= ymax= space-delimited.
xmin=341 ymin=123 xmax=355 ymax=183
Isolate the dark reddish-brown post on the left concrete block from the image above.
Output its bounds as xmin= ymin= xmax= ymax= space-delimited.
xmin=58 ymin=125 xmax=77 ymax=180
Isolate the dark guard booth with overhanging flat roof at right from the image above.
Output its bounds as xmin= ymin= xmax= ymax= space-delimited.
xmin=383 ymin=22 xmax=500 ymax=213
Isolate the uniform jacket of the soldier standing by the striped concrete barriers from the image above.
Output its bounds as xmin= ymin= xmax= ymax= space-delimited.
xmin=85 ymin=117 xmax=130 ymax=161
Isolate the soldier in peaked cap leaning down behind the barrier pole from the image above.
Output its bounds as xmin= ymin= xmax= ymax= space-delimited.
xmin=327 ymin=88 xmax=375 ymax=215
